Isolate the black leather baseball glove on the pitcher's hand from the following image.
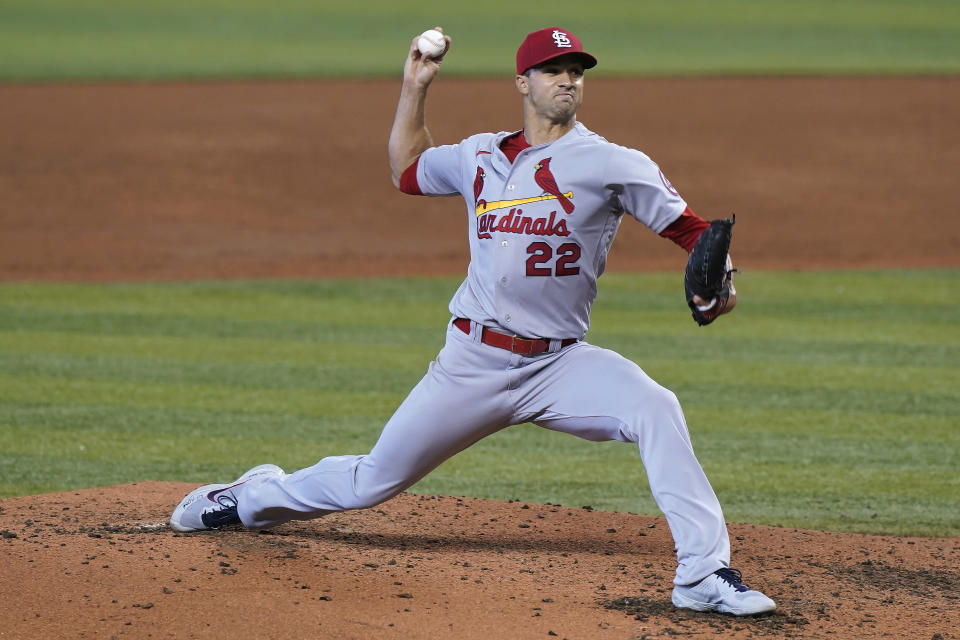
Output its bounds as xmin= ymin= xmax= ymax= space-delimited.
xmin=683 ymin=215 xmax=737 ymax=327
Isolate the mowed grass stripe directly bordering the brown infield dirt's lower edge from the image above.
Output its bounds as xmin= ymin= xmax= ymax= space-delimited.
xmin=2 ymin=270 xmax=960 ymax=316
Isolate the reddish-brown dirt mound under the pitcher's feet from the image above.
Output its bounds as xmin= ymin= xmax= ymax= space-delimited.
xmin=0 ymin=482 xmax=960 ymax=640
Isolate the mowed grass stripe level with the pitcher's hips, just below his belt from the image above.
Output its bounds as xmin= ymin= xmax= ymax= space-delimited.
xmin=7 ymin=344 xmax=960 ymax=396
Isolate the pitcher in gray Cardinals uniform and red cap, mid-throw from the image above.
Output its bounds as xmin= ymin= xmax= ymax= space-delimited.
xmin=170 ymin=27 xmax=775 ymax=615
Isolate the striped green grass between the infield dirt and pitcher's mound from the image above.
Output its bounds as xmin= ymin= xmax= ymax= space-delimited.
xmin=0 ymin=271 xmax=960 ymax=536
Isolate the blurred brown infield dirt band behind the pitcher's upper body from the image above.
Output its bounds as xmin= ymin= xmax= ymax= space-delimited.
xmin=0 ymin=77 xmax=960 ymax=278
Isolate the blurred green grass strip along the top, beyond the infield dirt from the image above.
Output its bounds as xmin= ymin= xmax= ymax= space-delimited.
xmin=0 ymin=0 xmax=960 ymax=82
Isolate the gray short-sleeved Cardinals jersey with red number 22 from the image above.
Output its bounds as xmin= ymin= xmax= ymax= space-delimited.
xmin=417 ymin=123 xmax=687 ymax=338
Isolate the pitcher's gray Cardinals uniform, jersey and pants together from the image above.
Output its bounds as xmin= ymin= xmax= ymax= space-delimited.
xmin=235 ymin=124 xmax=730 ymax=585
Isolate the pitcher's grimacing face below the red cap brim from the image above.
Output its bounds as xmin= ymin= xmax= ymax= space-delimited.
xmin=517 ymin=56 xmax=583 ymax=123
